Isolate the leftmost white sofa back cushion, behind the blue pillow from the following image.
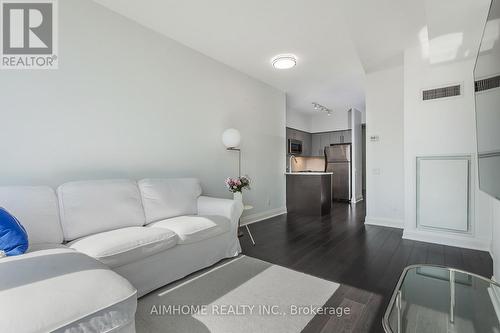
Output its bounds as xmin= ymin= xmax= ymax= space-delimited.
xmin=0 ymin=186 xmax=63 ymax=245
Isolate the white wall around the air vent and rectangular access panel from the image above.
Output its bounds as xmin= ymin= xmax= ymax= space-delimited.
xmin=404 ymin=47 xmax=491 ymax=250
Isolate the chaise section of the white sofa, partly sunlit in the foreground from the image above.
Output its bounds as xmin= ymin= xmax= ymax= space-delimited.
xmin=0 ymin=249 xmax=137 ymax=333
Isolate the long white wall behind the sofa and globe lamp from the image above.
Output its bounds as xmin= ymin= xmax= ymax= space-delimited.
xmin=0 ymin=0 xmax=285 ymax=220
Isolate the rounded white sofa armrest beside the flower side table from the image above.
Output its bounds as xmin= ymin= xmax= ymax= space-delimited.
xmin=198 ymin=196 xmax=243 ymax=230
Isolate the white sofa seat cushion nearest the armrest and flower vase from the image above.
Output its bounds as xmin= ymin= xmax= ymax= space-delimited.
xmin=147 ymin=215 xmax=229 ymax=244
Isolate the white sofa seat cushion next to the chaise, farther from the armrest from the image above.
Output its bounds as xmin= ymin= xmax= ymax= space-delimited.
xmin=67 ymin=227 xmax=177 ymax=268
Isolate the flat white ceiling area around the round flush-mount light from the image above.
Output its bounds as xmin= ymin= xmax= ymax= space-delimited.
xmin=97 ymin=0 xmax=374 ymax=112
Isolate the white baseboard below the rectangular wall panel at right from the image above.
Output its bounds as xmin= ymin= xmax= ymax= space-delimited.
xmin=403 ymin=230 xmax=490 ymax=252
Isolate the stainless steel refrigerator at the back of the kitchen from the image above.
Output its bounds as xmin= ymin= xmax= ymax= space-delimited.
xmin=325 ymin=143 xmax=352 ymax=201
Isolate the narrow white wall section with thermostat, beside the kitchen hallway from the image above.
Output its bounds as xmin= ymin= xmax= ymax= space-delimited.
xmin=366 ymin=66 xmax=404 ymax=228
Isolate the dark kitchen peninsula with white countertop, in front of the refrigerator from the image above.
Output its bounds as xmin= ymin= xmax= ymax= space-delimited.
xmin=286 ymin=172 xmax=333 ymax=215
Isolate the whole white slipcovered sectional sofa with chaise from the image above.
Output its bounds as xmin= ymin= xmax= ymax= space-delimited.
xmin=0 ymin=178 xmax=243 ymax=333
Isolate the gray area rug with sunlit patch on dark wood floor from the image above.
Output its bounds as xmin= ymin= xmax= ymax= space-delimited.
xmin=136 ymin=256 xmax=339 ymax=333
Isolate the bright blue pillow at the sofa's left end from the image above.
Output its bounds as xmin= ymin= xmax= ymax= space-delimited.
xmin=0 ymin=207 xmax=28 ymax=256
